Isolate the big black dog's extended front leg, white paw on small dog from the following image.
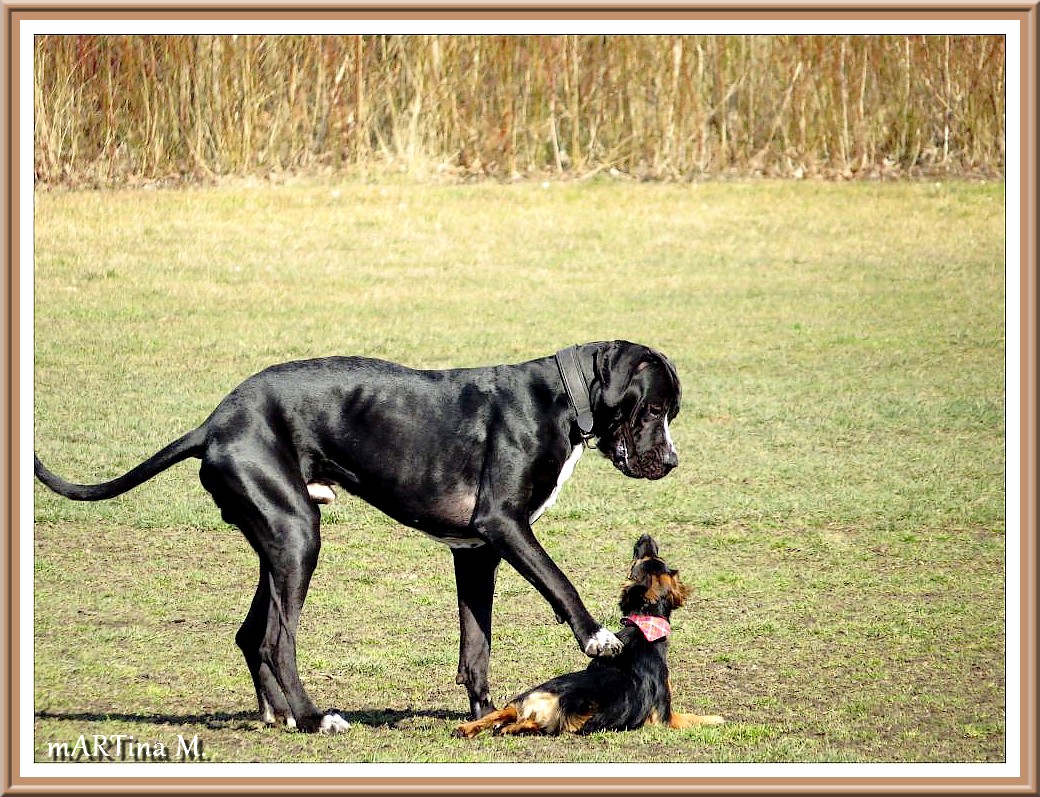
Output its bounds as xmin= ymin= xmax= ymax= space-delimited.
xmin=473 ymin=511 xmax=622 ymax=657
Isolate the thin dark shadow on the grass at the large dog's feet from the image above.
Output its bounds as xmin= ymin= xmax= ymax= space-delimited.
xmin=36 ymin=709 xmax=468 ymax=729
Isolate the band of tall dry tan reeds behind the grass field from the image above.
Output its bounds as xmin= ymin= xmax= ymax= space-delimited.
xmin=34 ymin=35 xmax=1005 ymax=183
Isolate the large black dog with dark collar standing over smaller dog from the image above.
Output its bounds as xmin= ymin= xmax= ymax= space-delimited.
xmin=35 ymin=340 xmax=680 ymax=732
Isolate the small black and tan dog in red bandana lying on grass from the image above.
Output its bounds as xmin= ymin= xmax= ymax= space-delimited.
xmin=456 ymin=534 xmax=724 ymax=738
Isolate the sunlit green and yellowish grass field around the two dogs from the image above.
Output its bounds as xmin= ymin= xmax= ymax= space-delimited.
xmin=34 ymin=179 xmax=1005 ymax=762
